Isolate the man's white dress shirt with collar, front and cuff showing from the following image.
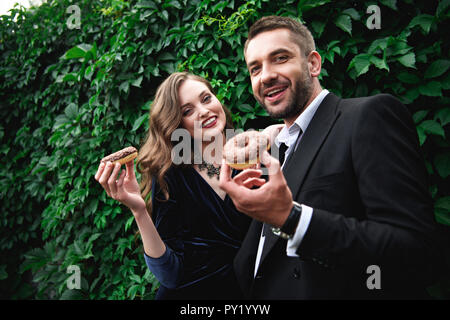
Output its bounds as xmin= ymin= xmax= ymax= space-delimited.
xmin=254 ymin=89 xmax=329 ymax=276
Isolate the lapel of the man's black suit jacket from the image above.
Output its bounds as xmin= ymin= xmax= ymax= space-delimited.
xmin=260 ymin=93 xmax=340 ymax=264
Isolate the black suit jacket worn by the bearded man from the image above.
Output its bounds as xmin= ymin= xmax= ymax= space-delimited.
xmin=234 ymin=93 xmax=440 ymax=299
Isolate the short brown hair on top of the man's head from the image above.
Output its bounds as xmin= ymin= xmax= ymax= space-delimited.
xmin=244 ymin=16 xmax=316 ymax=56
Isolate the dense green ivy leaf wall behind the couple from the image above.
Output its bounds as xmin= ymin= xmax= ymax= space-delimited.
xmin=0 ymin=0 xmax=450 ymax=299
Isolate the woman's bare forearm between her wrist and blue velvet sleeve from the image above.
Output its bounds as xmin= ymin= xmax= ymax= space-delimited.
xmin=133 ymin=208 xmax=166 ymax=258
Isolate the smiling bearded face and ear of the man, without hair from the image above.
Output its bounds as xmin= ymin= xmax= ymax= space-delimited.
xmin=245 ymin=29 xmax=321 ymax=124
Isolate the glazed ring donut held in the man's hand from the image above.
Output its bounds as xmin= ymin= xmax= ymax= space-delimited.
xmin=223 ymin=131 xmax=270 ymax=170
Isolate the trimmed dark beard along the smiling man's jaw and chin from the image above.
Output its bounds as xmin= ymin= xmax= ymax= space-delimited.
xmin=258 ymin=72 xmax=313 ymax=119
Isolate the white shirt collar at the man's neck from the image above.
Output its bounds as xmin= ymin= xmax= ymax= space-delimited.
xmin=275 ymin=89 xmax=329 ymax=147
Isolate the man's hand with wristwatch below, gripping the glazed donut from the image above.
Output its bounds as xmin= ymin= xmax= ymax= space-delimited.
xmin=219 ymin=151 xmax=293 ymax=227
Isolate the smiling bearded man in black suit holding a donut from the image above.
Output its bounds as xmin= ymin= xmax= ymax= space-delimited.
xmin=220 ymin=17 xmax=439 ymax=299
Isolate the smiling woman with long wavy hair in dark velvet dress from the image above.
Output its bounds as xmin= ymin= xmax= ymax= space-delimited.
xmin=95 ymin=72 xmax=282 ymax=299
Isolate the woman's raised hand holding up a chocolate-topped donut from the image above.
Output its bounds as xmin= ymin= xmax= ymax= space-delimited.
xmin=95 ymin=161 xmax=145 ymax=215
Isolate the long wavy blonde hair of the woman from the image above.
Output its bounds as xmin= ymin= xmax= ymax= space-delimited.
xmin=136 ymin=72 xmax=233 ymax=215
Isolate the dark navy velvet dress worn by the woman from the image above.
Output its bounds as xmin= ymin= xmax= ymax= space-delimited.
xmin=145 ymin=167 xmax=251 ymax=300
